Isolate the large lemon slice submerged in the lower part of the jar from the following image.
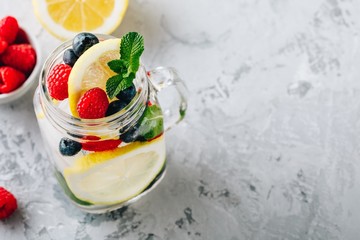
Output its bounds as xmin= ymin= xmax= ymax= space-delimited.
xmin=64 ymin=137 xmax=165 ymax=204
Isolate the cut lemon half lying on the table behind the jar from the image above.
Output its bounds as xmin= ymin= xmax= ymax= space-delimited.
xmin=32 ymin=0 xmax=128 ymax=40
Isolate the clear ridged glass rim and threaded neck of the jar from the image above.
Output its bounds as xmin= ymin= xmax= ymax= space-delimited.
xmin=39 ymin=34 xmax=150 ymax=138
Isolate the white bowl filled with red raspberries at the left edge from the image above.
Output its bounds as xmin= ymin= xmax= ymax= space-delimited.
xmin=0 ymin=16 xmax=40 ymax=104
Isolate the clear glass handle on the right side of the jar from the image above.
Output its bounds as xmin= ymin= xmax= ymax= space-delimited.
xmin=147 ymin=67 xmax=188 ymax=131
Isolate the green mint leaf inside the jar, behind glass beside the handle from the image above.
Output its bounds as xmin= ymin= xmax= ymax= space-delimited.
xmin=138 ymin=105 xmax=164 ymax=140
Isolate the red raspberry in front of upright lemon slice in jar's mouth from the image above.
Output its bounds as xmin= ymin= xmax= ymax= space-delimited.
xmin=77 ymin=87 xmax=109 ymax=119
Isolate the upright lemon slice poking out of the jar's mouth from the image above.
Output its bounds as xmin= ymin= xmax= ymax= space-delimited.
xmin=68 ymin=39 xmax=121 ymax=117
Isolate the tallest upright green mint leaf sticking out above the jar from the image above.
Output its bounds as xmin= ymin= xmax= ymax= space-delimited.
xmin=120 ymin=32 xmax=144 ymax=73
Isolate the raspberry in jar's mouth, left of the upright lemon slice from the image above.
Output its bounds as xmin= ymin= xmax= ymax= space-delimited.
xmin=47 ymin=64 xmax=71 ymax=100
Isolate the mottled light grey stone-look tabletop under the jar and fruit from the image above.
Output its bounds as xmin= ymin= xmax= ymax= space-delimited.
xmin=0 ymin=0 xmax=360 ymax=240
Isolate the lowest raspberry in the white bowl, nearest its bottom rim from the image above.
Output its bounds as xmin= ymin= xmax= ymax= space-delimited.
xmin=0 ymin=66 xmax=26 ymax=93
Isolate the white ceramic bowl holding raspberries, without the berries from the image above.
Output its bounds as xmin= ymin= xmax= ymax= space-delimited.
xmin=0 ymin=29 xmax=42 ymax=104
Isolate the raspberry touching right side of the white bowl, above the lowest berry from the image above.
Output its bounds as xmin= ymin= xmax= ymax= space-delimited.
xmin=0 ymin=44 xmax=36 ymax=74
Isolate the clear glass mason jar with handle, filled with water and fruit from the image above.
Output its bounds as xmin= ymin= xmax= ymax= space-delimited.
xmin=34 ymin=34 xmax=187 ymax=213
